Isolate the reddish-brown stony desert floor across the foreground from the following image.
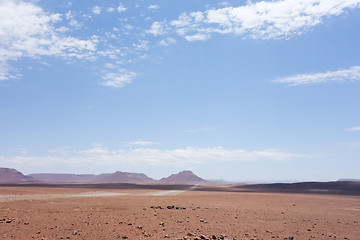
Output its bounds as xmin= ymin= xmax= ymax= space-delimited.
xmin=0 ymin=187 xmax=360 ymax=240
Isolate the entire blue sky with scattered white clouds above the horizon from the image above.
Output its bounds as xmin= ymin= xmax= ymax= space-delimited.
xmin=0 ymin=0 xmax=360 ymax=182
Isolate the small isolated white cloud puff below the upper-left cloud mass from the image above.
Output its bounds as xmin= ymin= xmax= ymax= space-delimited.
xmin=101 ymin=69 xmax=137 ymax=88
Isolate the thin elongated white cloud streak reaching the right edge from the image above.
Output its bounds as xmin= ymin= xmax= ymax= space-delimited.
xmin=274 ymin=66 xmax=360 ymax=86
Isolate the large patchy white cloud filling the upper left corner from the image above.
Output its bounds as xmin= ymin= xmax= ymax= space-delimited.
xmin=0 ymin=0 xmax=97 ymax=80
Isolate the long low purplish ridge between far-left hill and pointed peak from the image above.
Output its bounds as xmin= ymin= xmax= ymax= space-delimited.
xmin=29 ymin=171 xmax=154 ymax=183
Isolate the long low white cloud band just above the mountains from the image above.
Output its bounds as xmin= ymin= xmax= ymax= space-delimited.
xmin=0 ymin=144 xmax=307 ymax=167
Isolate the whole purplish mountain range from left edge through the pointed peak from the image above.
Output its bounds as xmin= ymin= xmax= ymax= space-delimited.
xmin=0 ymin=168 xmax=209 ymax=184
